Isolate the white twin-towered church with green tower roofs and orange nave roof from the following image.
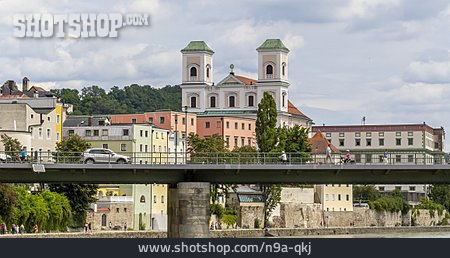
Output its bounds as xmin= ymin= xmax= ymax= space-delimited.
xmin=181 ymin=39 xmax=312 ymax=131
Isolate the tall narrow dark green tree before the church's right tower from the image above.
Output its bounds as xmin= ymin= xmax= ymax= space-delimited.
xmin=256 ymin=92 xmax=277 ymax=152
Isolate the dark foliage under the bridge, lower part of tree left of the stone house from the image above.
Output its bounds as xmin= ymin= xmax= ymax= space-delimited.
xmin=49 ymin=184 xmax=98 ymax=227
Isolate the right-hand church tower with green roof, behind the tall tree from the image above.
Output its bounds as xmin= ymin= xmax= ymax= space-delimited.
xmin=256 ymin=39 xmax=289 ymax=112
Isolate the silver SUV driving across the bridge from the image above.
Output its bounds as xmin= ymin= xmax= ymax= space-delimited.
xmin=81 ymin=148 xmax=131 ymax=164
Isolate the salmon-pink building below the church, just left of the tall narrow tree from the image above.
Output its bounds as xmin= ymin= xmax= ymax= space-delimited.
xmin=197 ymin=116 xmax=256 ymax=150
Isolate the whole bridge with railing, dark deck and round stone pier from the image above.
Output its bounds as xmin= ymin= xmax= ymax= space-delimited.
xmin=0 ymin=153 xmax=450 ymax=237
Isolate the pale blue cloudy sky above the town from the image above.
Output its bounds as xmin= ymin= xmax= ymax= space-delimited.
xmin=0 ymin=0 xmax=450 ymax=145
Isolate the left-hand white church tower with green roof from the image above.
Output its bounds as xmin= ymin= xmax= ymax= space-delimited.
xmin=181 ymin=41 xmax=214 ymax=112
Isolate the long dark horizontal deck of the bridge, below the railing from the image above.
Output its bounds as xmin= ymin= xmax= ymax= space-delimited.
xmin=0 ymin=163 xmax=450 ymax=184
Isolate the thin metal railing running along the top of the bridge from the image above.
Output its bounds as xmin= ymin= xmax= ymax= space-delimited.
xmin=0 ymin=151 xmax=449 ymax=165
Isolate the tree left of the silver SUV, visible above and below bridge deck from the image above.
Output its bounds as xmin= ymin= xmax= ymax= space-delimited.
xmin=49 ymin=135 xmax=98 ymax=227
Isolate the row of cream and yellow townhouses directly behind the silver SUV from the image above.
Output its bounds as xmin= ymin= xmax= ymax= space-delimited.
xmin=63 ymin=115 xmax=186 ymax=164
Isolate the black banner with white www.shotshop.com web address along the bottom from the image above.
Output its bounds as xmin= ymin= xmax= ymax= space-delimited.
xmin=0 ymin=238 xmax=449 ymax=258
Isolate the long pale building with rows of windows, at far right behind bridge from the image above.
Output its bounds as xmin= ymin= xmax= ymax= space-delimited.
xmin=312 ymin=123 xmax=445 ymax=204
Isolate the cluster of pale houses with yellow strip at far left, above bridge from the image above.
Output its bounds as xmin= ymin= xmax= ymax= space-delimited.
xmin=0 ymin=77 xmax=72 ymax=158
